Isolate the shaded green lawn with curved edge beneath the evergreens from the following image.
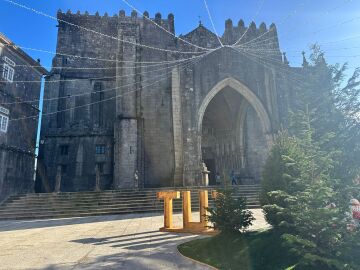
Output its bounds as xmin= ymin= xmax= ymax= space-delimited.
xmin=178 ymin=230 xmax=297 ymax=270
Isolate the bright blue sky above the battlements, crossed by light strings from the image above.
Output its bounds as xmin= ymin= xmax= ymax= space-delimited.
xmin=0 ymin=0 xmax=360 ymax=75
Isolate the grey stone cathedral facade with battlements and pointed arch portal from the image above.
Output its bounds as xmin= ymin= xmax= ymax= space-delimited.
xmin=38 ymin=11 xmax=297 ymax=191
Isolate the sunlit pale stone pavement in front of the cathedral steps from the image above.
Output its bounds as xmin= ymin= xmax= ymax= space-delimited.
xmin=0 ymin=209 xmax=267 ymax=270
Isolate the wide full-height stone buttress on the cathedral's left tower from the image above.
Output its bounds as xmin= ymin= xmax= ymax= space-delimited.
xmin=113 ymin=23 xmax=140 ymax=189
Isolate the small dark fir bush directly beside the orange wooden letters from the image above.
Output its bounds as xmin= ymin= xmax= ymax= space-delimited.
xmin=207 ymin=189 xmax=254 ymax=232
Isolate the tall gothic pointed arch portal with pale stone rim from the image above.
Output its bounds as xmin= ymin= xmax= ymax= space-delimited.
xmin=197 ymin=77 xmax=272 ymax=184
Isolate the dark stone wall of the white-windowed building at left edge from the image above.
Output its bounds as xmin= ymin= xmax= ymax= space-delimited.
xmin=0 ymin=40 xmax=46 ymax=201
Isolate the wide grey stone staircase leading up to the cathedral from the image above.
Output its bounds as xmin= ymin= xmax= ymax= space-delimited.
xmin=0 ymin=185 xmax=260 ymax=220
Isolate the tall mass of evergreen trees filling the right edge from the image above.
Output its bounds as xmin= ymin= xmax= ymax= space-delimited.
xmin=261 ymin=47 xmax=360 ymax=270
